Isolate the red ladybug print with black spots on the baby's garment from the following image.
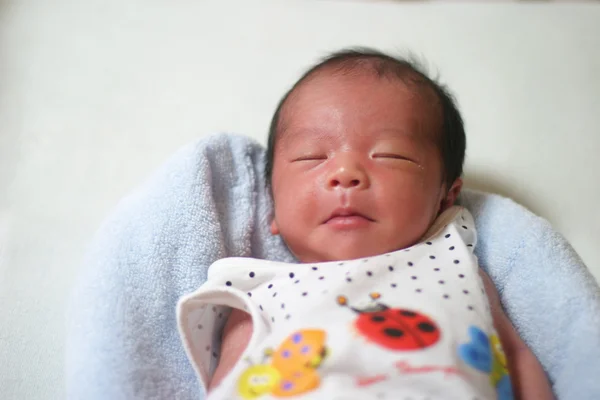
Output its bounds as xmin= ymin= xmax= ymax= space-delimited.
xmin=337 ymin=293 xmax=441 ymax=351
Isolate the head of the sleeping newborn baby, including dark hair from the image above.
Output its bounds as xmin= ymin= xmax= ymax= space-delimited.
xmin=266 ymin=49 xmax=466 ymax=262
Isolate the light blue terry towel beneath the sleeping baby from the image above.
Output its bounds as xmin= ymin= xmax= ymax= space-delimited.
xmin=66 ymin=135 xmax=600 ymax=400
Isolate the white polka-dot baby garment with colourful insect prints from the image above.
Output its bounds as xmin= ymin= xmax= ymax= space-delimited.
xmin=178 ymin=207 xmax=512 ymax=400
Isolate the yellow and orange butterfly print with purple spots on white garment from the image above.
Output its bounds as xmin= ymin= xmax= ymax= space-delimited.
xmin=237 ymin=329 xmax=327 ymax=400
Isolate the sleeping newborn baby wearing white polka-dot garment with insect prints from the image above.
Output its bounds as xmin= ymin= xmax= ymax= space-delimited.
xmin=178 ymin=50 xmax=552 ymax=400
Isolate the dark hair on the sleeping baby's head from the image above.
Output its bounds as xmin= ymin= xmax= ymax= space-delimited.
xmin=265 ymin=48 xmax=466 ymax=189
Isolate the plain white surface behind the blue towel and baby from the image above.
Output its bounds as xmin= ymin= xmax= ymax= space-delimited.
xmin=0 ymin=0 xmax=600 ymax=400
